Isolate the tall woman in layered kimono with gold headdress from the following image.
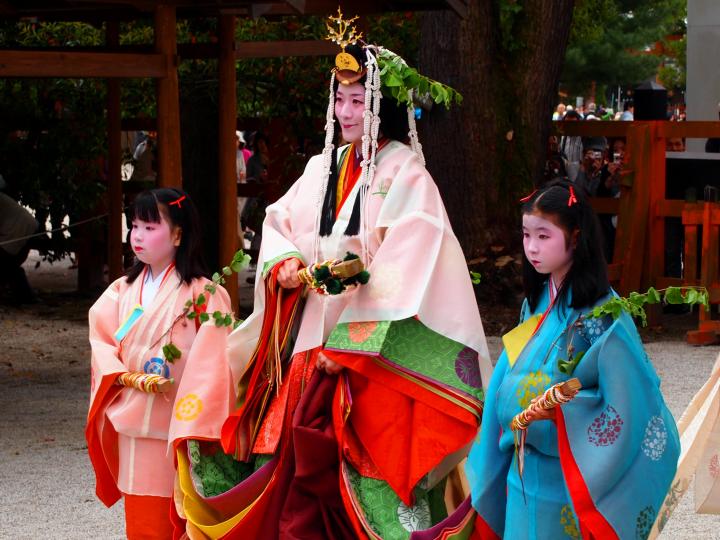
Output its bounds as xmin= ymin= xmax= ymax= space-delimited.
xmin=172 ymin=11 xmax=490 ymax=539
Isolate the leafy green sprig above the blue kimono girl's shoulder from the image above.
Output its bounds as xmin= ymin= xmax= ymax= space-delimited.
xmin=587 ymin=287 xmax=710 ymax=326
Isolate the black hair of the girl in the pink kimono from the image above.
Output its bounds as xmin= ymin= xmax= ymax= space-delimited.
xmin=126 ymin=188 xmax=210 ymax=284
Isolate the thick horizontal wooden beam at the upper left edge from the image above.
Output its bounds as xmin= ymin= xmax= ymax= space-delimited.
xmin=0 ymin=50 xmax=168 ymax=78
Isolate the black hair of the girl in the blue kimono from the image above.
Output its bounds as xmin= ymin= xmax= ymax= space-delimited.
xmin=522 ymin=180 xmax=610 ymax=311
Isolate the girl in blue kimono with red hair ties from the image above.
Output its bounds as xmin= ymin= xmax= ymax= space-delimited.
xmin=466 ymin=182 xmax=680 ymax=540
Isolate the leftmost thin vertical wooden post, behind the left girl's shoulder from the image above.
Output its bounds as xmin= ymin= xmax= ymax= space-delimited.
xmin=106 ymin=21 xmax=123 ymax=282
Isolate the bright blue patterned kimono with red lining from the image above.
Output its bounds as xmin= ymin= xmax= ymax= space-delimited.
xmin=466 ymin=289 xmax=680 ymax=540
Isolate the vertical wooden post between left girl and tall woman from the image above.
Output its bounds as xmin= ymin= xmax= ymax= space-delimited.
xmin=218 ymin=15 xmax=242 ymax=311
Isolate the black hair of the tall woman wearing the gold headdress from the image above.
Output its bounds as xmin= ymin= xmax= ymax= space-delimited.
xmin=320 ymin=44 xmax=410 ymax=236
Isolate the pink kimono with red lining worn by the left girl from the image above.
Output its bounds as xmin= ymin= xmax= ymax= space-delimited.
xmin=85 ymin=271 xmax=234 ymax=506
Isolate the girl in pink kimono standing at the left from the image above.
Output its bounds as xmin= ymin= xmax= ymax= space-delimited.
xmin=85 ymin=188 xmax=230 ymax=539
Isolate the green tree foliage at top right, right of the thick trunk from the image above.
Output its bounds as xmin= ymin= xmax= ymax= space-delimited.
xmin=560 ymin=0 xmax=687 ymax=94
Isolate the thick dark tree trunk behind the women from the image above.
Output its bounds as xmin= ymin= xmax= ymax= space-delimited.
xmin=420 ymin=0 xmax=574 ymax=258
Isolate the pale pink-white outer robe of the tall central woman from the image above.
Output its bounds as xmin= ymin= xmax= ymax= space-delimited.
xmin=229 ymin=141 xmax=492 ymax=384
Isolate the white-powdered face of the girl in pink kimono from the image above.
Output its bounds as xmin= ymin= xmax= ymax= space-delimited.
xmin=130 ymin=212 xmax=180 ymax=277
